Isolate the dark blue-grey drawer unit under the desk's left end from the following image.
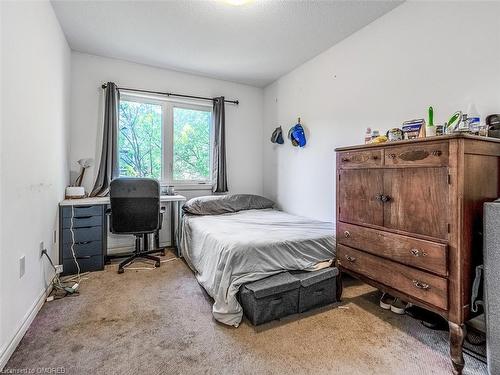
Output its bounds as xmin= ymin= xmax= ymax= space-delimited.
xmin=59 ymin=204 xmax=107 ymax=275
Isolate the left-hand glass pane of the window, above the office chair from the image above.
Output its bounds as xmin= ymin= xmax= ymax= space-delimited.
xmin=118 ymin=100 xmax=162 ymax=179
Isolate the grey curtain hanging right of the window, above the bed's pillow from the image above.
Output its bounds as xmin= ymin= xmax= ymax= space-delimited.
xmin=212 ymin=96 xmax=228 ymax=193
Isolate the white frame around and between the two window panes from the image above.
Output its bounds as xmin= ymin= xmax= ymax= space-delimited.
xmin=118 ymin=92 xmax=214 ymax=190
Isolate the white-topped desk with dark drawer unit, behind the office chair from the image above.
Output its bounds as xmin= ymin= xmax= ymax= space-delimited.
xmin=59 ymin=195 xmax=186 ymax=275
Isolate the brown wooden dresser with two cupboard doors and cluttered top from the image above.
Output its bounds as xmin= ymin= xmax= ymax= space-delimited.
xmin=336 ymin=135 xmax=500 ymax=373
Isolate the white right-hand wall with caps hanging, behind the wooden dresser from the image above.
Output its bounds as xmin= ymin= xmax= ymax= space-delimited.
xmin=263 ymin=2 xmax=500 ymax=221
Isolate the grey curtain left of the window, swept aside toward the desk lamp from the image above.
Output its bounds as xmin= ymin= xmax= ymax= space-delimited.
xmin=90 ymin=82 xmax=120 ymax=197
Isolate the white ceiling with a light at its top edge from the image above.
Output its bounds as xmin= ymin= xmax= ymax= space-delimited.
xmin=52 ymin=0 xmax=401 ymax=87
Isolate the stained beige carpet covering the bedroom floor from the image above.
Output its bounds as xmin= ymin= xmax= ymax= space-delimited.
xmin=6 ymin=254 xmax=486 ymax=375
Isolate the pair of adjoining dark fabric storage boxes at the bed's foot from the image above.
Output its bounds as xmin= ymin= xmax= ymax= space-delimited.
xmin=240 ymin=267 xmax=339 ymax=325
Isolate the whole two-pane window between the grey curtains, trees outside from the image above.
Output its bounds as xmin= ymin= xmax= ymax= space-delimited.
xmin=118 ymin=95 xmax=212 ymax=184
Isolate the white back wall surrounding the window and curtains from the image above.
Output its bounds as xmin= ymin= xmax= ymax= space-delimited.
xmin=70 ymin=52 xmax=263 ymax=248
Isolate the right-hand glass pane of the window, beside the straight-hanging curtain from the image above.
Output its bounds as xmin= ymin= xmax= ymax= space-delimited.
xmin=173 ymin=107 xmax=212 ymax=181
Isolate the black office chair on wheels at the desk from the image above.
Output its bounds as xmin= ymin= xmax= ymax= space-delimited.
xmin=108 ymin=178 xmax=165 ymax=273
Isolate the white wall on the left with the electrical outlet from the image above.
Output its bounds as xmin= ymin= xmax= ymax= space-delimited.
xmin=0 ymin=1 xmax=70 ymax=368
